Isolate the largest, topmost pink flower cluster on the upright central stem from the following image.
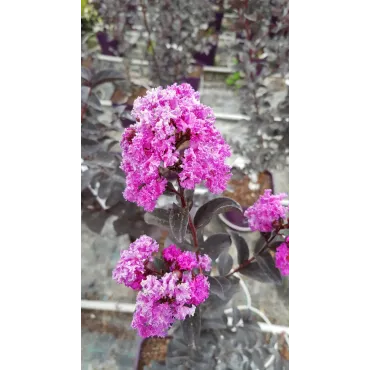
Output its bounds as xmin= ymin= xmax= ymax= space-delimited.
xmin=121 ymin=84 xmax=231 ymax=211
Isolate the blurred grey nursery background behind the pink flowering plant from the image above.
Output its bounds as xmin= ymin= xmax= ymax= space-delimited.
xmin=80 ymin=0 xmax=295 ymax=370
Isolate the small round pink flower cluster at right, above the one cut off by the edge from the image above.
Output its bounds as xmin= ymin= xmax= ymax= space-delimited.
xmin=244 ymin=189 xmax=289 ymax=232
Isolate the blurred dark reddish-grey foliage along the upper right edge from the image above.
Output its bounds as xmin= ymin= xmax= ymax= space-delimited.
xmin=227 ymin=0 xmax=289 ymax=172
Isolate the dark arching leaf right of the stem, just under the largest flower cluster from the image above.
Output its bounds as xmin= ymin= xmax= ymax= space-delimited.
xmin=194 ymin=197 xmax=243 ymax=228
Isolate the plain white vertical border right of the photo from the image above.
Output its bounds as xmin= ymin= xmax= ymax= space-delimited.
xmin=298 ymin=1 xmax=370 ymax=370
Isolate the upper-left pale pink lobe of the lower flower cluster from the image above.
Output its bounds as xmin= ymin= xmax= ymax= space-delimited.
xmin=112 ymin=235 xmax=159 ymax=290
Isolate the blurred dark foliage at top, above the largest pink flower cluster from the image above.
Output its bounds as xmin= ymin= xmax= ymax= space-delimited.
xmin=89 ymin=0 xmax=215 ymax=86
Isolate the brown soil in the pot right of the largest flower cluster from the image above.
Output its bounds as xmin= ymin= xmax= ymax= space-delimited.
xmin=224 ymin=172 xmax=272 ymax=207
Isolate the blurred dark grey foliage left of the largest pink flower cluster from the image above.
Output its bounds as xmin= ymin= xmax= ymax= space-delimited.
xmin=80 ymin=67 xmax=157 ymax=238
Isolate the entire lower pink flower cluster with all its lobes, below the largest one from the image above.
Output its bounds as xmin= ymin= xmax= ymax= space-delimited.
xmin=113 ymin=235 xmax=212 ymax=337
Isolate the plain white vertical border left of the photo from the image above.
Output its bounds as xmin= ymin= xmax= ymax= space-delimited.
xmin=0 ymin=0 xmax=80 ymax=370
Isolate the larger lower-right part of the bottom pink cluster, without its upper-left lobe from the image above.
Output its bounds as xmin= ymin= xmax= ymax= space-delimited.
xmin=132 ymin=271 xmax=209 ymax=338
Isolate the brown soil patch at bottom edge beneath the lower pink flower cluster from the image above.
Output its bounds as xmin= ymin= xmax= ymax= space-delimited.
xmin=137 ymin=338 xmax=170 ymax=370
